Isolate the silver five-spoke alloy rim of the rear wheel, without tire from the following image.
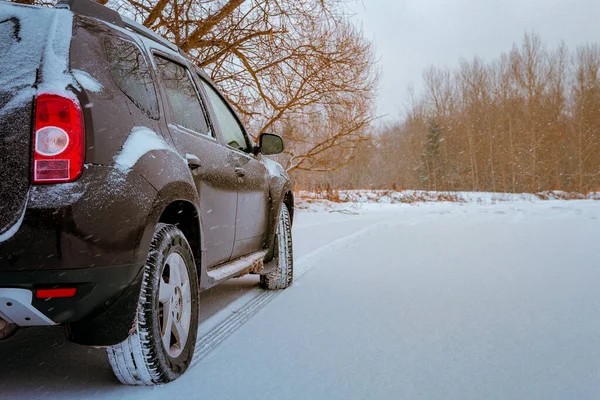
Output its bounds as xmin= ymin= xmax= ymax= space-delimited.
xmin=158 ymin=253 xmax=192 ymax=358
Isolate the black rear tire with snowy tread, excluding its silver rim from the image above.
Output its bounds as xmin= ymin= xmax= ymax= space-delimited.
xmin=107 ymin=224 xmax=199 ymax=385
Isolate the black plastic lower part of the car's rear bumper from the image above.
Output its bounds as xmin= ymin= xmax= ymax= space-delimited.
xmin=0 ymin=265 xmax=144 ymax=346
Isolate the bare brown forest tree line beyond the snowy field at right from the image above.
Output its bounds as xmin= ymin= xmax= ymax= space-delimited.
xmin=295 ymin=34 xmax=600 ymax=192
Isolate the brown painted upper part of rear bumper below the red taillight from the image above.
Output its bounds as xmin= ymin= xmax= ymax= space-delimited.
xmin=0 ymin=165 xmax=157 ymax=271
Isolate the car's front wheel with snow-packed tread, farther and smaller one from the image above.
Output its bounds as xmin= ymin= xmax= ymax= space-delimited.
xmin=260 ymin=204 xmax=294 ymax=290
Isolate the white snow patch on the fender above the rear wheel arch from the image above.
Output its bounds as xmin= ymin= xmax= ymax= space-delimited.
xmin=115 ymin=126 xmax=177 ymax=173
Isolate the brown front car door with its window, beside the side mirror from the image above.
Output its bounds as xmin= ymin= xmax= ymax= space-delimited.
xmin=200 ymin=78 xmax=270 ymax=258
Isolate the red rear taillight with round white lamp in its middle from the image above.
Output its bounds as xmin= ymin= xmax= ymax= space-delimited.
xmin=33 ymin=94 xmax=85 ymax=183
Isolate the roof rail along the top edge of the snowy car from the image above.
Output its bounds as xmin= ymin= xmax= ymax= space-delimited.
xmin=55 ymin=0 xmax=179 ymax=52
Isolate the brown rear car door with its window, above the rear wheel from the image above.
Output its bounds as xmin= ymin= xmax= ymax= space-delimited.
xmin=154 ymin=53 xmax=238 ymax=268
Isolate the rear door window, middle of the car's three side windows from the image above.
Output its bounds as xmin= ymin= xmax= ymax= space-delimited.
xmin=154 ymin=55 xmax=211 ymax=135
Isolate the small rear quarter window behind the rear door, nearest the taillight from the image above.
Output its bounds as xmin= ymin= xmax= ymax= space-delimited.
xmin=104 ymin=37 xmax=158 ymax=119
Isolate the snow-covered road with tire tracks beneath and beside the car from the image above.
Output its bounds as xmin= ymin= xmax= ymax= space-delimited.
xmin=0 ymin=201 xmax=600 ymax=400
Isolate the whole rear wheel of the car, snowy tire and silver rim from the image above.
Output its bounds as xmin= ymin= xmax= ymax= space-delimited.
xmin=107 ymin=224 xmax=198 ymax=385
